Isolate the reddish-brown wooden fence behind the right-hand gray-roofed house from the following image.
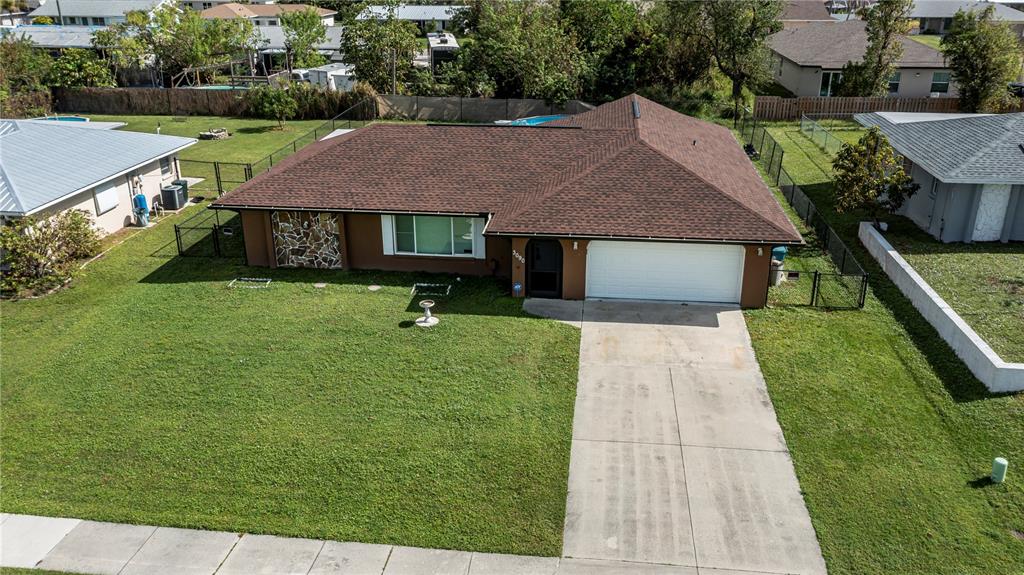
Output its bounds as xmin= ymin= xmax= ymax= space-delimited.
xmin=754 ymin=96 xmax=959 ymax=120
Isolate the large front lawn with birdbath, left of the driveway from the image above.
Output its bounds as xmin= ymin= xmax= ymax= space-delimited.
xmin=0 ymin=202 xmax=579 ymax=556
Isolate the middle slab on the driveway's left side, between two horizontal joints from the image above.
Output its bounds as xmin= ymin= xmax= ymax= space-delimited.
xmin=572 ymin=365 xmax=679 ymax=444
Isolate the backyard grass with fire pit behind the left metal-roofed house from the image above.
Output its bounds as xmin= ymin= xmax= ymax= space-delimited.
xmin=87 ymin=114 xmax=324 ymax=164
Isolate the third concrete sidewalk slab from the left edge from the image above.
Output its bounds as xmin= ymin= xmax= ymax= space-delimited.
xmin=121 ymin=527 xmax=239 ymax=575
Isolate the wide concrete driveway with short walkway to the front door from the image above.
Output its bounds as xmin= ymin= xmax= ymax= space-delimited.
xmin=527 ymin=301 xmax=825 ymax=575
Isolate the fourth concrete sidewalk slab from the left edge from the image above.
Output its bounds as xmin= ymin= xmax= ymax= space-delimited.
xmin=217 ymin=534 xmax=324 ymax=575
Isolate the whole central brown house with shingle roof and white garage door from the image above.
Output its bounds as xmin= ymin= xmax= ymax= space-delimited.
xmin=212 ymin=95 xmax=802 ymax=307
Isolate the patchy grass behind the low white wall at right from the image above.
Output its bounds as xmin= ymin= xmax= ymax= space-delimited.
xmin=885 ymin=222 xmax=1024 ymax=362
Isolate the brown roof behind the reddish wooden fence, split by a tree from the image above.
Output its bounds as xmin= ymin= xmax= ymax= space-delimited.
xmin=768 ymin=20 xmax=946 ymax=69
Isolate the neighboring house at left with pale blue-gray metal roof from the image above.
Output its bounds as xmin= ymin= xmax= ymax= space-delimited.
xmin=0 ymin=120 xmax=196 ymax=233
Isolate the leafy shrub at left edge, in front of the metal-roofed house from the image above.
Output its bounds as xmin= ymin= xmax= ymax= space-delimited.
xmin=0 ymin=210 xmax=99 ymax=296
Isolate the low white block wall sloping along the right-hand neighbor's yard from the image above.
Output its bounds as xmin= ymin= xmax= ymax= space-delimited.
xmin=857 ymin=222 xmax=1024 ymax=392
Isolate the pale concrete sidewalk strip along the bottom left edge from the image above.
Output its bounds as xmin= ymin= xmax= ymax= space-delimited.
xmin=0 ymin=514 xmax=696 ymax=575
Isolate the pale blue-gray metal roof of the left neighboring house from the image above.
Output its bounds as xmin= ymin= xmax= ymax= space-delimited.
xmin=0 ymin=120 xmax=196 ymax=216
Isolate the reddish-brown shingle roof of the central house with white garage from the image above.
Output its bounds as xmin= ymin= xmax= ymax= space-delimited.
xmin=214 ymin=96 xmax=801 ymax=244
